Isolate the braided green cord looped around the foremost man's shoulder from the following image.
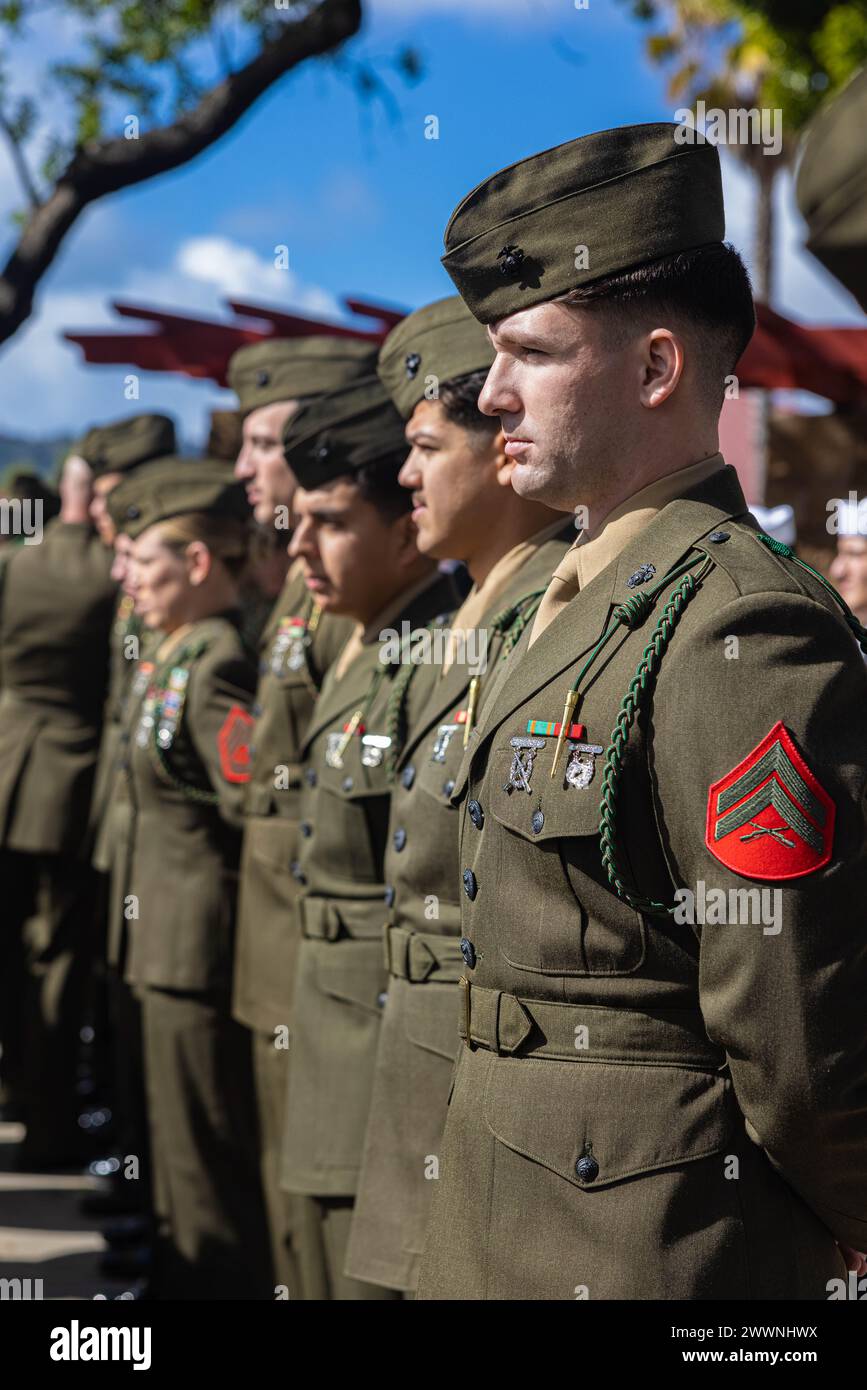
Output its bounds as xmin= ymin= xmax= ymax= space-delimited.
xmin=578 ymin=550 xmax=714 ymax=916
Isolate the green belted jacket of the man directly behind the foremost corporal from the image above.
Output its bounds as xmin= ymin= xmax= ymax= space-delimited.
xmin=347 ymin=517 xmax=575 ymax=1290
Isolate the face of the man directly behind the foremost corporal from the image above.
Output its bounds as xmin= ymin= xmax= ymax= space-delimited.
xmin=399 ymin=400 xmax=507 ymax=560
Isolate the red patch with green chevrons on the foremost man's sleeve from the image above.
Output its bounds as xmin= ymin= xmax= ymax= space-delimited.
xmin=704 ymin=720 xmax=836 ymax=878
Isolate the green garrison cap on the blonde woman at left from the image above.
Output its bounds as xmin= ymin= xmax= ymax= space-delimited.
xmin=106 ymin=457 xmax=250 ymax=539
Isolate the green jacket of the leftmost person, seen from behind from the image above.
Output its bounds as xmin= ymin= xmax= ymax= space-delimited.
xmin=0 ymin=518 xmax=117 ymax=855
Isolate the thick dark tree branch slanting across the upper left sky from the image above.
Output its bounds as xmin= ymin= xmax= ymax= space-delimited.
xmin=0 ymin=0 xmax=361 ymax=343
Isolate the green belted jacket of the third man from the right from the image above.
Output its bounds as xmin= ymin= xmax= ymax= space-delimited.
xmin=281 ymin=575 xmax=456 ymax=1195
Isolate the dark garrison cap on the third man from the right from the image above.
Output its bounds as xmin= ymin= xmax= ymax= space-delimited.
xmin=283 ymin=375 xmax=408 ymax=489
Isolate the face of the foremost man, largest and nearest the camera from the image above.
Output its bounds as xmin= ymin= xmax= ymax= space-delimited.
xmin=479 ymin=303 xmax=641 ymax=525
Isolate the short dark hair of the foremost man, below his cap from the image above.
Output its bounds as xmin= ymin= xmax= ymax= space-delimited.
xmin=561 ymin=242 xmax=756 ymax=406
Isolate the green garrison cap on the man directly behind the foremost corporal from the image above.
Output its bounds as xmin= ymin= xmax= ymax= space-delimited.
xmin=377 ymin=295 xmax=495 ymax=420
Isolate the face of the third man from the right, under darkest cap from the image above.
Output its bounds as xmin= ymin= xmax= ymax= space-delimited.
xmin=289 ymin=478 xmax=417 ymax=623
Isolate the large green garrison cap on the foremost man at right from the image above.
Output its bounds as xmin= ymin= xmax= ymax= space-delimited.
xmin=442 ymin=122 xmax=725 ymax=324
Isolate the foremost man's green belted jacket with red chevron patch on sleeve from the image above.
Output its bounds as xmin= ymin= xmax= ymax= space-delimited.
xmin=420 ymin=468 xmax=867 ymax=1300
